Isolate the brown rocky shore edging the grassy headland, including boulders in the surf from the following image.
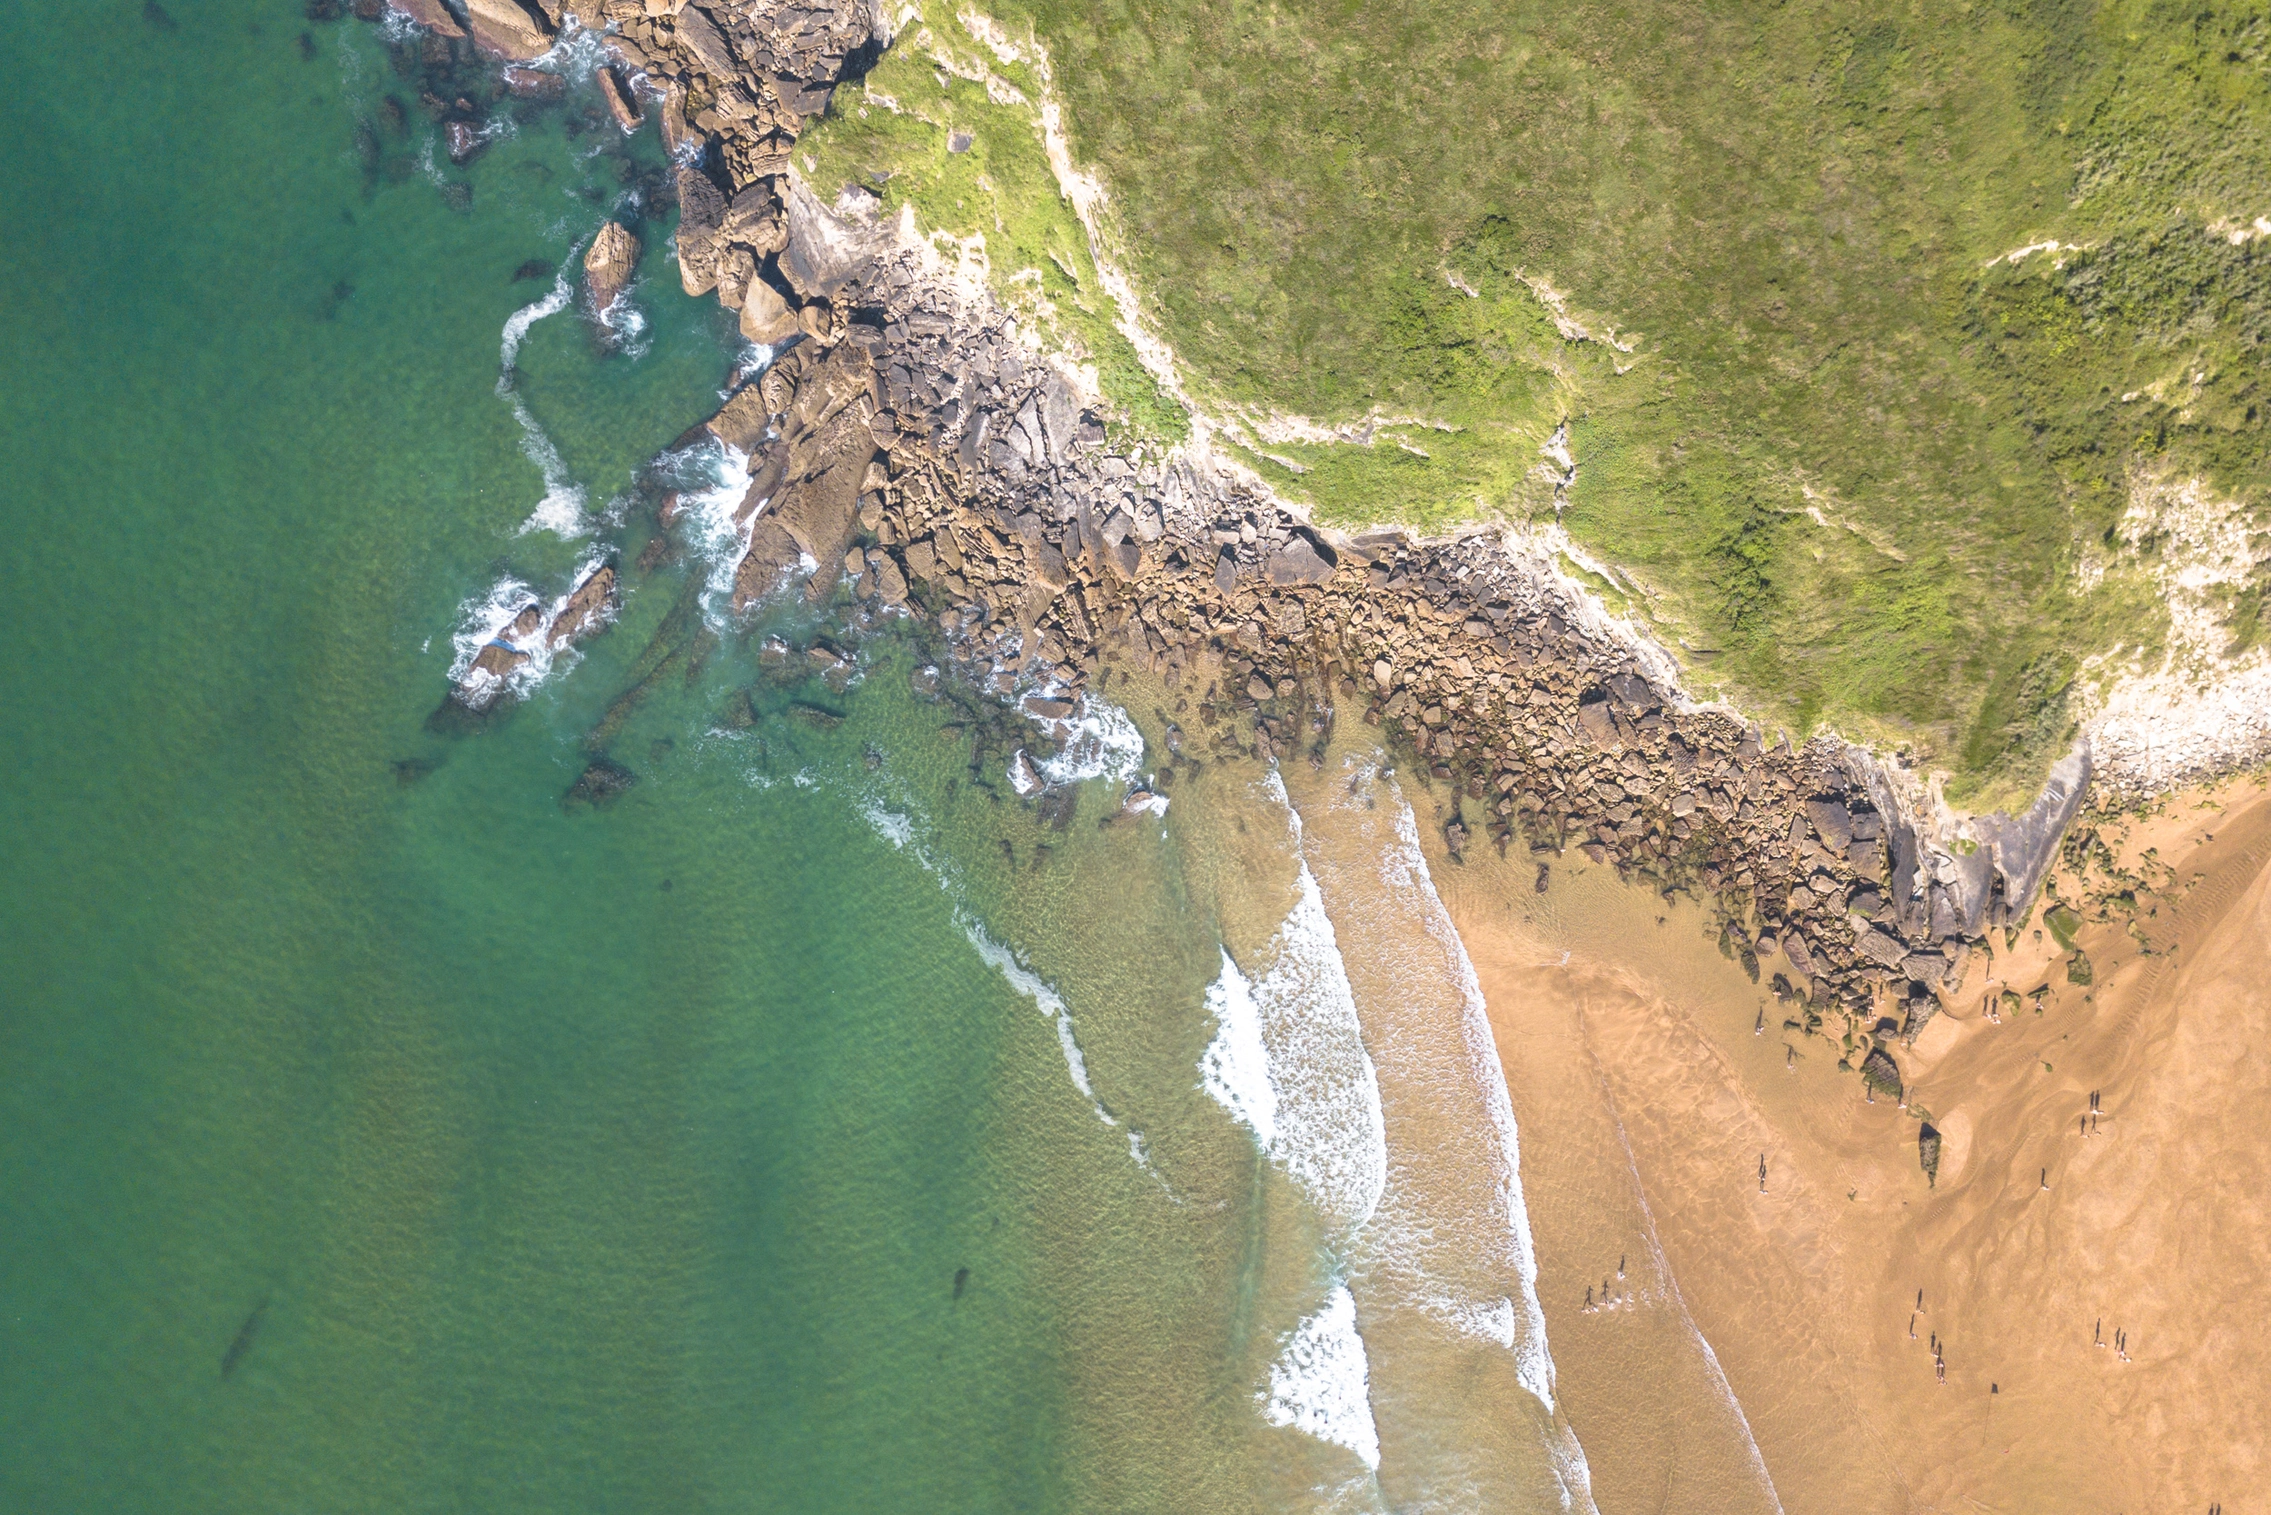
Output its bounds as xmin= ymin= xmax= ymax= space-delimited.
xmin=395 ymin=0 xmax=2171 ymax=1103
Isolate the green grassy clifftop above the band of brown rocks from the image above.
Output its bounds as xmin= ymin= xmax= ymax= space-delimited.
xmin=813 ymin=0 xmax=2271 ymax=800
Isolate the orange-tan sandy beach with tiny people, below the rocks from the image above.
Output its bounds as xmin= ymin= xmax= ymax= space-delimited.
xmin=1422 ymin=779 xmax=2271 ymax=1515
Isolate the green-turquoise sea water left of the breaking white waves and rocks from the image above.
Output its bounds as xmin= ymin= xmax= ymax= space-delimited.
xmin=0 ymin=0 xmax=1598 ymax=1513
